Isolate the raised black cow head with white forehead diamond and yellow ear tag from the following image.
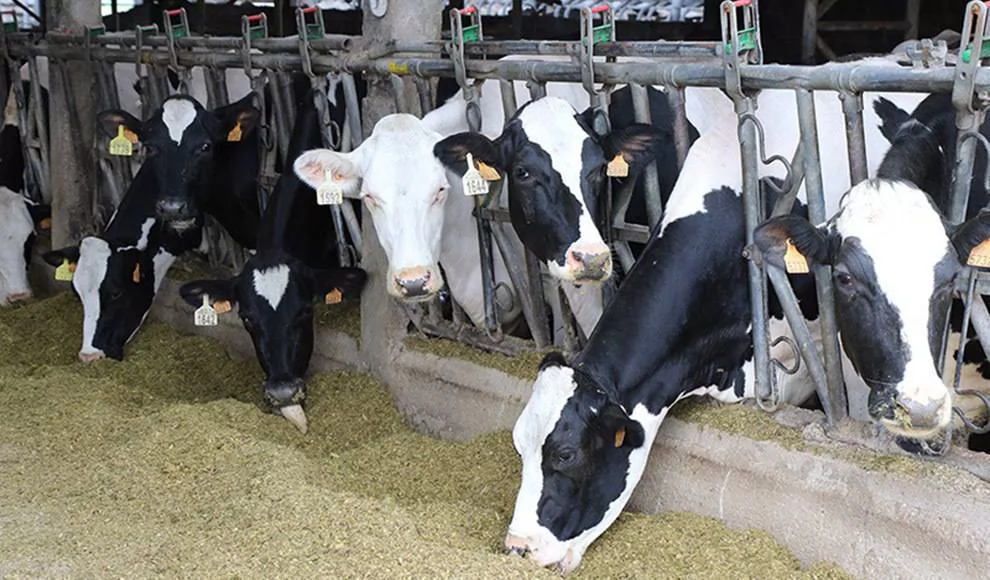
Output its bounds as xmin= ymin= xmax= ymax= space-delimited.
xmin=99 ymin=95 xmax=259 ymax=230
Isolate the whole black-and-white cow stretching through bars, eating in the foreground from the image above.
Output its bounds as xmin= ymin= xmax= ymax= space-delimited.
xmin=505 ymin=82 xmax=922 ymax=573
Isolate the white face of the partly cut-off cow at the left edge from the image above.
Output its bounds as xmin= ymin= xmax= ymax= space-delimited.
xmin=0 ymin=187 xmax=34 ymax=306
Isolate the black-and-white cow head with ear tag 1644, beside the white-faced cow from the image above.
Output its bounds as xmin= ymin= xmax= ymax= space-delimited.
xmin=434 ymin=97 xmax=665 ymax=282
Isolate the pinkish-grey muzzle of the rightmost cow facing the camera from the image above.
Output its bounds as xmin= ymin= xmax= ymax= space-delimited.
xmin=869 ymin=382 xmax=952 ymax=438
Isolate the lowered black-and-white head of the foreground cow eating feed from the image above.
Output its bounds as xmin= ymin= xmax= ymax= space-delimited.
xmin=505 ymin=353 xmax=659 ymax=573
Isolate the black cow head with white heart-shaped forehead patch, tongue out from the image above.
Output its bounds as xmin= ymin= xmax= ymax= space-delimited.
xmin=179 ymin=254 xmax=366 ymax=433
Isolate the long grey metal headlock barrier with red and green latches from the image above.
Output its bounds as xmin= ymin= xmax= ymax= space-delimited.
xmin=0 ymin=0 xmax=990 ymax=451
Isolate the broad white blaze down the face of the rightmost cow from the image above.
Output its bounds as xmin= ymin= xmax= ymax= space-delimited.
xmin=835 ymin=181 xmax=954 ymax=404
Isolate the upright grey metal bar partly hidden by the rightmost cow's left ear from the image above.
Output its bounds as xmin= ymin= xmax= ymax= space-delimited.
xmin=796 ymin=89 xmax=846 ymax=424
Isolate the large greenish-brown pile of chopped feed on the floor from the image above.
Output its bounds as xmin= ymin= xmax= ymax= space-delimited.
xmin=0 ymin=294 xmax=843 ymax=578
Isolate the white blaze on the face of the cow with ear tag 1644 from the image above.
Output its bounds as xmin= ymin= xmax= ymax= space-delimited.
xmin=518 ymin=97 xmax=612 ymax=282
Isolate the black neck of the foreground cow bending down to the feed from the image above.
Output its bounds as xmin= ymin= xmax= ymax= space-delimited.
xmin=573 ymin=188 xmax=750 ymax=414
